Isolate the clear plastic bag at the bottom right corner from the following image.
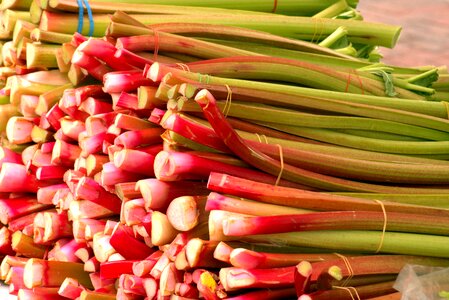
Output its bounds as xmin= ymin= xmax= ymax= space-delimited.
xmin=394 ymin=265 xmax=449 ymax=300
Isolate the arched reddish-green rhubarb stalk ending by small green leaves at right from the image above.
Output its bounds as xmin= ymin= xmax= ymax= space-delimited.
xmin=184 ymin=56 xmax=423 ymax=100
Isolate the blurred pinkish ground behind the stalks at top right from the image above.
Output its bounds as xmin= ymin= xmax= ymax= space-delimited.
xmin=357 ymin=0 xmax=449 ymax=66
